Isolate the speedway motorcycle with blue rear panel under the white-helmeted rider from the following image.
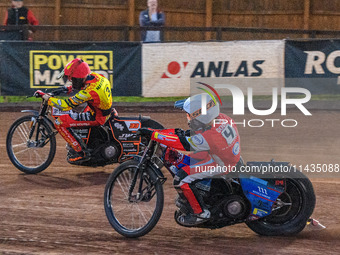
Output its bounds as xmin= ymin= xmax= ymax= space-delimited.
xmin=104 ymin=132 xmax=315 ymax=238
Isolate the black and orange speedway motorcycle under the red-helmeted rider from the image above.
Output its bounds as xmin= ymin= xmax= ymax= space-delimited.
xmin=6 ymin=87 xmax=163 ymax=174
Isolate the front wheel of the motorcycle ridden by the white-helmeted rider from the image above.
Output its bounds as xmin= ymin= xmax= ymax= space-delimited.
xmin=104 ymin=160 xmax=164 ymax=237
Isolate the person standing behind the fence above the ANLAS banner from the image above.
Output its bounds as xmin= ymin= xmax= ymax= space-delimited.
xmin=139 ymin=0 xmax=165 ymax=42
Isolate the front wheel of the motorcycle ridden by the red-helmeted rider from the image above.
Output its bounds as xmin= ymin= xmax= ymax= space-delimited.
xmin=6 ymin=115 xmax=56 ymax=174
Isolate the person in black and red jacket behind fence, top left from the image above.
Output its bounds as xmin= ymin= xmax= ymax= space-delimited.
xmin=4 ymin=0 xmax=39 ymax=40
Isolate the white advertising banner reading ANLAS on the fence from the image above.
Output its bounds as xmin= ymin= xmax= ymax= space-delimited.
xmin=142 ymin=41 xmax=284 ymax=97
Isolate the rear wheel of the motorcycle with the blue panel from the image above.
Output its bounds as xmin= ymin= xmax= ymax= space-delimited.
xmin=247 ymin=171 xmax=315 ymax=236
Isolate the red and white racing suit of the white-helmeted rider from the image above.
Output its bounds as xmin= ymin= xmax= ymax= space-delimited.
xmin=151 ymin=114 xmax=241 ymax=215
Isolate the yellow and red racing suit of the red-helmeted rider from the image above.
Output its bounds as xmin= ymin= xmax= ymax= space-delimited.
xmin=48 ymin=72 xmax=113 ymax=155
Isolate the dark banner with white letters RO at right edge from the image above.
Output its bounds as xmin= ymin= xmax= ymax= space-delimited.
xmin=285 ymin=40 xmax=340 ymax=94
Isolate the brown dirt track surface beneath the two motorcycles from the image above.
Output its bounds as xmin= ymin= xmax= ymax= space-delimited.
xmin=0 ymin=108 xmax=340 ymax=254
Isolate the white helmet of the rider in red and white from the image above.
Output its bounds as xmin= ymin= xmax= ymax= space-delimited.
xmin=183 ymin=93 xmax=220 ymax=125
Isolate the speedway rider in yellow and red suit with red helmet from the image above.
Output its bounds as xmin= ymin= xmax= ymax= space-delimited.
xmin=36 ymin=58 xmax=113 ymax=162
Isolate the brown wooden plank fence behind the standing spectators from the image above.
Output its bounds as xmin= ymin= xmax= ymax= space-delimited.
xmin=0 ymin=0 xmax=340 ymax=41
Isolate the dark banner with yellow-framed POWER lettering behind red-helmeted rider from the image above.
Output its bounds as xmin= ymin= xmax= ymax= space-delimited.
xmin=0 ymin=42 xmax=141 ymax=96
